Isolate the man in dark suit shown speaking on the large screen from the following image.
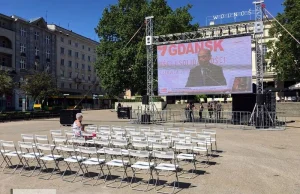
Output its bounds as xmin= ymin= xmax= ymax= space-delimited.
xmin=185 ymin=49 xmax=226 ymax=87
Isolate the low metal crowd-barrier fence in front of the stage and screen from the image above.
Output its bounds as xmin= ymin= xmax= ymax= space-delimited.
xmin=131 ymin=109 xmax=286 ymax=130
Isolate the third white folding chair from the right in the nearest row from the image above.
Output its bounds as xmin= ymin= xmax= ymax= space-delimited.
xmin=104 ymin=148 xmax=129 ymax=188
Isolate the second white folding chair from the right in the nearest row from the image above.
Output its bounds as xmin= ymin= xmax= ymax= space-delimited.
xmin=129 ymin=150 xmax=154 ymax=191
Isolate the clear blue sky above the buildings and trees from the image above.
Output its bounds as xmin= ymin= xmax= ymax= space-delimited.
xmin=0 ymin=0 xmax=283 ymax=40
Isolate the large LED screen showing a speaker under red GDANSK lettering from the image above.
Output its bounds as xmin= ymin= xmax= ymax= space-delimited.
xmin=157 ymin=36 xmax=252 ymax=96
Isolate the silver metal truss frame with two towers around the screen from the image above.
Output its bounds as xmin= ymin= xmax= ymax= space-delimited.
xmin=145 ymin=0 xmax=267 ymax=126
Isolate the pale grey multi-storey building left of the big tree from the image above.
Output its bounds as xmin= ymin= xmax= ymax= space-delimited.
xmin=48 ymin=24 xmax=102 ymax=96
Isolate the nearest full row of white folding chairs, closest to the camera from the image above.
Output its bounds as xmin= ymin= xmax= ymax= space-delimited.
xmin=0 ymin=138 xmax=207 ymax=192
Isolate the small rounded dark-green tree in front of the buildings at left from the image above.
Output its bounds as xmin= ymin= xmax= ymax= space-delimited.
xmin=21 ymin=72 xmax=58 ymax=104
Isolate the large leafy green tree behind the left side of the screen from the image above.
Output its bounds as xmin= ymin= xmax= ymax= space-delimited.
xmin=95 ymin=0 xmax=198 ymax=95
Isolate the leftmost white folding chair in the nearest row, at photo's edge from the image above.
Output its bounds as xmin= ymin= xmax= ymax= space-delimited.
xmin=1 ymin=141 xmax=24 ymax=174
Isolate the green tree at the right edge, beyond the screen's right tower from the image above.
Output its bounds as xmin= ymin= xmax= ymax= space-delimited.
xmin=267 ymin=0 xmax=300 ymax=80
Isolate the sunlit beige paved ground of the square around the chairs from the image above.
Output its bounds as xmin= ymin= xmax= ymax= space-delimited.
xmin=0 ymin=110 xmax=300 ymax=194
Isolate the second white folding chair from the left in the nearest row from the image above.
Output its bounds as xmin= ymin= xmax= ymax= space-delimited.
xmin=18 ymin=141 xmax=43 ymax=176
